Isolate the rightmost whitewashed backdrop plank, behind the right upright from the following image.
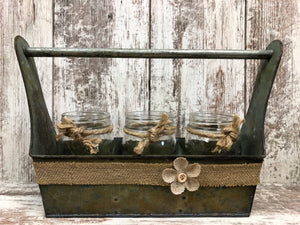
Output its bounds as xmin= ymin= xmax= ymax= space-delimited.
xmin=246 ymin=0 xmax=300 ymax=184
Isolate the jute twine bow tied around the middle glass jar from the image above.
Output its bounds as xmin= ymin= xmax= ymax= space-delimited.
xmin=123 ymin=113 xmax=176 ymax=155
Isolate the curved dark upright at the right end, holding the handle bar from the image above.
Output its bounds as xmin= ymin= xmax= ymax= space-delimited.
xmin=232 ymin=40 xmax=282 ymax=156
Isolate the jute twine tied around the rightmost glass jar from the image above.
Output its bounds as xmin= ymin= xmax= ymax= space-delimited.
xmin=186 ymin=114 xmax=245 ymax=153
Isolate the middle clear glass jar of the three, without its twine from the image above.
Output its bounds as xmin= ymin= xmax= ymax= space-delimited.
xmin=123 ymin=111 xmax=176 ymax=155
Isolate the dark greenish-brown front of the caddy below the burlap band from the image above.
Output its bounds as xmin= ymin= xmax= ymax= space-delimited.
xmin=40 ymin=185 xmax=256 ymax=217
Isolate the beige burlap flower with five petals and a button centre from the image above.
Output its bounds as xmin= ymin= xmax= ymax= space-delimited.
xmin=162 ymin=157 xmax=201 ymax=195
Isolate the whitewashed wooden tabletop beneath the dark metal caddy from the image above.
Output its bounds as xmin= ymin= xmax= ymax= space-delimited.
xmin=0 ymin=184 xmax=300 ymax=225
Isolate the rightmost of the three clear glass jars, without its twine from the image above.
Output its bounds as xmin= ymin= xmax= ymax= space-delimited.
xmin=185 ymin=112 xmax=233 ymax=155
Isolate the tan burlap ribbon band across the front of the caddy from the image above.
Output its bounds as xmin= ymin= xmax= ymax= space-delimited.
xmin=33 ymin=162 xmax=262 ymax=187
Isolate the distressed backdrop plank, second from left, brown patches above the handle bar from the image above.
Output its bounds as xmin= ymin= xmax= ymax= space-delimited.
xmin=54 ymin=0 xmax=149 ymax=136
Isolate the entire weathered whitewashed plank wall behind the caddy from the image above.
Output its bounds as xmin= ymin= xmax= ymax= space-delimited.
xmin=0 ymin=0 xmax=300 ymax=185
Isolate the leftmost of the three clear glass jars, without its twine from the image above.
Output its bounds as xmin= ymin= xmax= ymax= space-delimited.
xmin=61 ymin=111 xmax=118 ymax=155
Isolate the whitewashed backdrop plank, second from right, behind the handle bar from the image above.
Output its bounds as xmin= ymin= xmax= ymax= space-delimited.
xmin=151 ymin=0 xmax=245 ymax=136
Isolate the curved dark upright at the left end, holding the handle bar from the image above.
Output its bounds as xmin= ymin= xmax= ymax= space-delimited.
xmin=15 ymin=36 xmax=57 ymax=155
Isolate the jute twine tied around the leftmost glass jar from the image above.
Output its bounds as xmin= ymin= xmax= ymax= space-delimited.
xmin=56 ymin=116 xmax=113 ymax=154
